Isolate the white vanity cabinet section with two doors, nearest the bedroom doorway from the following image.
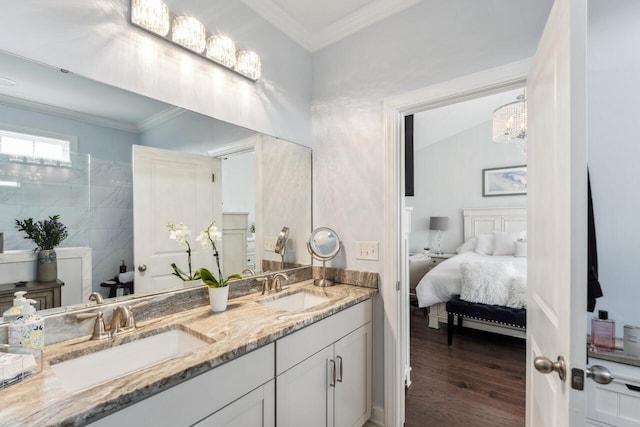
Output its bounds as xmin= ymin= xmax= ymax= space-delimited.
xmin=276 ymin=300 xmax=372 ymax=427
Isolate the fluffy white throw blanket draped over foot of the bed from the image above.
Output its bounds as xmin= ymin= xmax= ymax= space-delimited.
xmin=460 ymin=262 xmax=515 ymax=305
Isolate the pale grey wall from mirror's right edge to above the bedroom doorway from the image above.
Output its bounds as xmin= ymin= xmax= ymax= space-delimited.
xmin=312 ymin=0 xmax=552 ymax=406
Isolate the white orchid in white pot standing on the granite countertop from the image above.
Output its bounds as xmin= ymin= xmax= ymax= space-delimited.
xmin=196 ymin=221 xmax=242 ymax=312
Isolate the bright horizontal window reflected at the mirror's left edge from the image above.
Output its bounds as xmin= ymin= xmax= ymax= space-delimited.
xmin=0 ymin=129 xmax=71 ymax=162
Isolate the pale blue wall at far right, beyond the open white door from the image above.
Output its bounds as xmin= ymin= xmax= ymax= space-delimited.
xmin=588 ymin=0 xmax=640 ymax=337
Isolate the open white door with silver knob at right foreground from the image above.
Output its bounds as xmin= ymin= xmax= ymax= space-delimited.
xmin=527 ymin=0 xmax=587 ymax=427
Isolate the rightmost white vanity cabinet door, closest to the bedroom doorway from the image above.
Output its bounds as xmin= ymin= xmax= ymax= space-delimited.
xmin=334 ymin=323 xmax=372 ymax=427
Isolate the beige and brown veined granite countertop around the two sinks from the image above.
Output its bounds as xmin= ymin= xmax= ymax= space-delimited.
xmin=0 ymin=280 xmax=377 ymax=426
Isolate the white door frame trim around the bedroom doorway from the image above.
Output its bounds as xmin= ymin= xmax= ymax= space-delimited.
xmin=381 ymin=61 xmax=530 ymax=425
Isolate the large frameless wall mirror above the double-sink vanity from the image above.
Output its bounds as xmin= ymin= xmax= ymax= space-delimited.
xmin=0 ymin=48 xmax=312 ymax=312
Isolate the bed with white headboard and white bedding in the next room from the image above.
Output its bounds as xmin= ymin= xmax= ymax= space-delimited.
xmin=416 ymin=207 xmax=527 ymax=338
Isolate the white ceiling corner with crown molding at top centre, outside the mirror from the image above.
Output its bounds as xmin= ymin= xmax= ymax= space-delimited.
xmin=242 ymin=0 xmax=422 ymax=52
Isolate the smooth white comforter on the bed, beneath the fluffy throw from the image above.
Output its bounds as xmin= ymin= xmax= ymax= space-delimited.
xmin=416 ymin=252 xmax=527 ymax=307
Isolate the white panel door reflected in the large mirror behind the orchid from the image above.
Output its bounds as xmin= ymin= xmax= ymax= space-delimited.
xmin=133 ymin=145 xmax=222 ymax=293
